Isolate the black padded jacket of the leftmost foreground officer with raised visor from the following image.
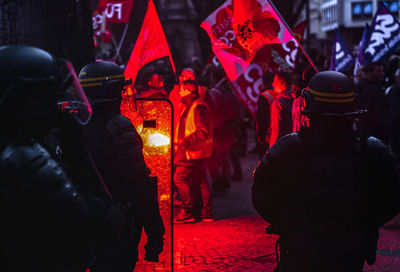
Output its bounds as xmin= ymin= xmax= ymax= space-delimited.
xmin=0 ymin=137 xmax=90 ymax=272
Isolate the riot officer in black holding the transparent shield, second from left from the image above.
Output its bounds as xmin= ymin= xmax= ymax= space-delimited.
xmin=79 ymin=61 xmax=165 ymax=272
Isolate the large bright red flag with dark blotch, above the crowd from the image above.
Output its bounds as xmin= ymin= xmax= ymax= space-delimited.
xmin=201 ymin=0 xmax=293 ymax=81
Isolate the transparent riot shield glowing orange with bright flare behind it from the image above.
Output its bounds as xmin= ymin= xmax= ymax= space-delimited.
xmin=121 ymin=96 xmax=173 ymax=272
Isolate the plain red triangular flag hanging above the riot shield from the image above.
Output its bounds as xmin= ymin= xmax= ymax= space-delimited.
xmin=124 ymin=0 xmax=176 ymax=83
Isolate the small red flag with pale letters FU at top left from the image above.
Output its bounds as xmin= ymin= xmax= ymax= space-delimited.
xmin=93 ymin=0 xmax=134 ymax=24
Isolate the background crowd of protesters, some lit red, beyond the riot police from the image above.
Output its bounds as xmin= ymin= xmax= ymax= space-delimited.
xmin=137 ymin=53 xmax=400 ymax=230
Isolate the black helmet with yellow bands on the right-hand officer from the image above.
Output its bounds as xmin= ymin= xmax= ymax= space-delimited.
xmin=302 ymin=71 xmax=361 ymax=117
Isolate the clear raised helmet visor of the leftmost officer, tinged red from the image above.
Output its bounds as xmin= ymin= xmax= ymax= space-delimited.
xmin=57 ymin=59 xmax=92 ymax=125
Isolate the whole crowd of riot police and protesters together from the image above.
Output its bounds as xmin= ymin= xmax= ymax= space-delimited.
xmin=0 ymin=38 xmax=400 ymax=272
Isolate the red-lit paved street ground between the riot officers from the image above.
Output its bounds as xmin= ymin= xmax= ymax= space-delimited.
xmin=135 ymin=135 xmax=400 ymax=272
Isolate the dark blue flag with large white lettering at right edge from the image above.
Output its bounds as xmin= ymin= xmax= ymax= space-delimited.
xmin=362 ymin=2 xmax=400 ymax=65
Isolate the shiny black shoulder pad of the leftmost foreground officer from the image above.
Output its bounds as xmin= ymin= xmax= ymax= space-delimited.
xmin=0 ymin=141 xmax=50 ymax=173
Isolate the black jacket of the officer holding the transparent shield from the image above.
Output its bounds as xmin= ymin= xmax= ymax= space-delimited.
xmin=83 ymin=101 xmax=165 ymax=262
